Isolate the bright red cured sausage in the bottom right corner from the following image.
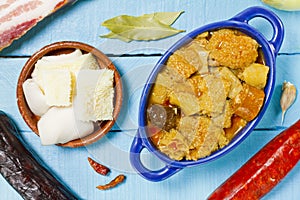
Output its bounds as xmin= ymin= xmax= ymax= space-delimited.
xmin=208 ymin=120 xmax=300 ymax=200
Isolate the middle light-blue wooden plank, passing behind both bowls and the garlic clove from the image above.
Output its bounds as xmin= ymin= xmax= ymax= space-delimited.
xmin=0 ymin=55 xmax=300 ymax=131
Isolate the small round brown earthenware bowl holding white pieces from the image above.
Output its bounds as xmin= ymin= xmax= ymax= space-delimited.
xmin=17 ymin=41 xmax=122 ymax=147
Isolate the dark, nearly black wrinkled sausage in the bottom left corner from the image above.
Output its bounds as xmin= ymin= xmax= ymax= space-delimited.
xmin=0 ymin=111 xmax=77 ymax=200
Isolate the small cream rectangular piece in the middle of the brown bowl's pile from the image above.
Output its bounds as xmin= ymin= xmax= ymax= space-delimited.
xmin=41 ymin=69 xmax=72 ymax=106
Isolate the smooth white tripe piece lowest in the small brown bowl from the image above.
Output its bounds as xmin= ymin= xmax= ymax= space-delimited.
xmin=37 ymin=107 xmax=94 ymax=145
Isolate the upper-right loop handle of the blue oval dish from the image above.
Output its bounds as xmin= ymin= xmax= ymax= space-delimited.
xmin=230 ymin=6 xmax=284 ymax=55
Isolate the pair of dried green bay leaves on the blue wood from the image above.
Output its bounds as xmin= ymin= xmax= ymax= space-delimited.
xmin=101 ymin=12 xmax=184 ymax=42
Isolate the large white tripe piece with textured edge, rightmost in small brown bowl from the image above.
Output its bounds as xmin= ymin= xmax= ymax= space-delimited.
xmin=74 ymin=69 xmax=114 ymax=121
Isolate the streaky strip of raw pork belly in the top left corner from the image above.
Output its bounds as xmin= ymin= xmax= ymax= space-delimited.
xmin=0 ymin=0 xmax=76 ymax=51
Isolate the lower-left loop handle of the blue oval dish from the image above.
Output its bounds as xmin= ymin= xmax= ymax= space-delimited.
xmin=130 ymin=130 xmax=182 ymax=182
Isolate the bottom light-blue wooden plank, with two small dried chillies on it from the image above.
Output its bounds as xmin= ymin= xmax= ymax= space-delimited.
xmin=0 ymin=131 xmax=300 ymax=200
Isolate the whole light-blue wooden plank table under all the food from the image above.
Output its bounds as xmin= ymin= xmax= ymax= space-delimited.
xmin=0 ymin=0 xmax=300 ymax=200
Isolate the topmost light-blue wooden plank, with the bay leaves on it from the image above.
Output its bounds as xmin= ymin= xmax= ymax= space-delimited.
xmin=0 ymin=0 xmax=300 ymax=56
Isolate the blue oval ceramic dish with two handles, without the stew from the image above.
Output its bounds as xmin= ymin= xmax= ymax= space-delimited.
xmin=130 ymin=7 xmax=284 ymax=181
